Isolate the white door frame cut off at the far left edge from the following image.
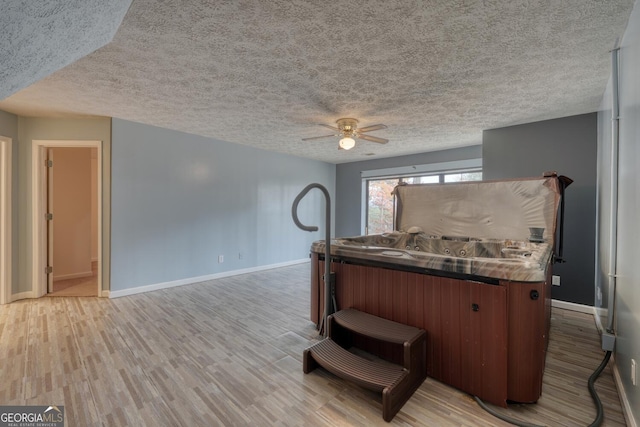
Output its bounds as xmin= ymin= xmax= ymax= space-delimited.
xmin=0 ymin=136 xmax=13 ymax=304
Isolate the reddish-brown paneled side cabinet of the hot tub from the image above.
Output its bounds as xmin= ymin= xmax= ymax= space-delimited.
xmin=311 ymin=252 xmax=551 ymax=407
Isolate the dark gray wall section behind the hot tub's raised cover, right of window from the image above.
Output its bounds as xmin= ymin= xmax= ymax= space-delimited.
xmin=482 ymin=113 xmax=598 ymax=305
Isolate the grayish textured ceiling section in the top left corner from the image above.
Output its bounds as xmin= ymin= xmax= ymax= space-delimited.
xmin=0 ymin=0 xmax=131 ymax=99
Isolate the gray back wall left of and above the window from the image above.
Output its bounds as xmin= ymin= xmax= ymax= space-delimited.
xmin=336 ymin=145 xmax=482 ymax=236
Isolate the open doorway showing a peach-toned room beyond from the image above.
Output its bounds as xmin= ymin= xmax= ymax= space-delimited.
xmin=32 ymin=140 xmax=102 ymax=297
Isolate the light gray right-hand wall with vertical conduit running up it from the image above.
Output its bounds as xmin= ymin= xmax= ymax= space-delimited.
xmin=596 ymin=2 xmax=640 ymax=425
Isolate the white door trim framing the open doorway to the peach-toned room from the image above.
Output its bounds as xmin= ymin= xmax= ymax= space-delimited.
xmin=31 ymin=139 xmax=102 ymax=298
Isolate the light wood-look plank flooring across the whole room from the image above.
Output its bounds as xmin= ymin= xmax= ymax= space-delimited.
xmin=0 ymin=264 xmax=625 ymax=427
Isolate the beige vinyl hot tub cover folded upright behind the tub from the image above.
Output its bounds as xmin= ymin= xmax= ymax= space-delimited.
xmin=394 ymin=173 xmax=571 ymax=241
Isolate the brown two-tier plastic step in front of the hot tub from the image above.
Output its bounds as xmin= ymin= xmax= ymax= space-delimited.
xmin=302 ymin=309 xmax=427 ymax=421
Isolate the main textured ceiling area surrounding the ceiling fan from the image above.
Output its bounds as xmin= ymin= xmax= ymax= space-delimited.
xmin=0 ymin=0 xmax=634 ymax=163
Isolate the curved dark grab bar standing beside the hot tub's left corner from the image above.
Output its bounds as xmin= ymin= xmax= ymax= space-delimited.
xmin=291 ymin=183 xmax=337 ymax=337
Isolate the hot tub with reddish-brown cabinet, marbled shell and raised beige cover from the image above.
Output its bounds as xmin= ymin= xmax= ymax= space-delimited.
xmin=310 ymin=174 xmax=571 ymax=406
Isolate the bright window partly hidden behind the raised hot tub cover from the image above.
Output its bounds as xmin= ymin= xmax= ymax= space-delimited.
xmin=365 ymin=170 xmax=482 ymax=234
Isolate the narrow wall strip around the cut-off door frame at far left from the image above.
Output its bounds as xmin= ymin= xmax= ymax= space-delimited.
xmin=0 ymin=110 xmax=20 ymax=293
